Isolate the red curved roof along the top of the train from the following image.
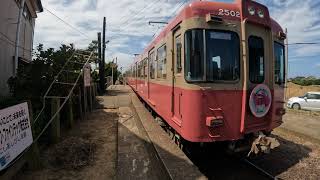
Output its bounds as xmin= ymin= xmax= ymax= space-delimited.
xmin=134 ymin=0 xmax=283 ymax=62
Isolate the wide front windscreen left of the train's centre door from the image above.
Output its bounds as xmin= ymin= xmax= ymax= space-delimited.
xmin=206 ymin=30 xmax=240 ymax=81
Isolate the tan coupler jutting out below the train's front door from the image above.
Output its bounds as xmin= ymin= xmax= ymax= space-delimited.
xmin=247 ymin=132 xmax=280 ymax=157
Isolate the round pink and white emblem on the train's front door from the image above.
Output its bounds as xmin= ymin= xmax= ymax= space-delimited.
xmin=249 ymin=84 xmax=272 ymax=118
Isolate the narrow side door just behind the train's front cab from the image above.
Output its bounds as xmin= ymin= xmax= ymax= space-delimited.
xmin=171 ymin=26 xmax=182 ymax=126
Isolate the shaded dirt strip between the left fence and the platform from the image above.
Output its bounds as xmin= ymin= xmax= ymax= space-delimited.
xmin=14 ymin=109 xmax=118 ymax=180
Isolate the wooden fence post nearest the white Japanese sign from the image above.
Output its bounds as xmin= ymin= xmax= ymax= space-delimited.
xmin=50 ymin=99 xmax=61 ymax=143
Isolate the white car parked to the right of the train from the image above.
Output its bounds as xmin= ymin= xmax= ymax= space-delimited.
xmin=287 ymin=92 xmax=320 ymax=111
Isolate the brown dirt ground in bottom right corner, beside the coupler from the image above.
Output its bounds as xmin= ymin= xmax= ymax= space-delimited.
xmin=253 ymin=128 xmax=320 ymax=180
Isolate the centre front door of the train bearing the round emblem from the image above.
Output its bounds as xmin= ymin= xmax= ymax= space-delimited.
xmin=243 ymin=24 xmax=273 ymax=132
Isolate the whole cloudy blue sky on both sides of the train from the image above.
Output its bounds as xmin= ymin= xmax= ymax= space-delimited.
xmin=34 ymin=0 xmax=320 ymax=77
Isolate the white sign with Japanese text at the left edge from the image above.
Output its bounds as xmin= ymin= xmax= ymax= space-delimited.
xmin=0 ymin=103 xmax=33 ymax=171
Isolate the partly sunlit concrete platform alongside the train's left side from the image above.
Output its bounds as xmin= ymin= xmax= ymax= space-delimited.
xmin=104 ymin=85 xmax=206 ymax=179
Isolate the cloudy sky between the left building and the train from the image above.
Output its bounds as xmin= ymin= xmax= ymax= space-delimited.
xmin=34 ymin=0 xmax=185 ymax=69
